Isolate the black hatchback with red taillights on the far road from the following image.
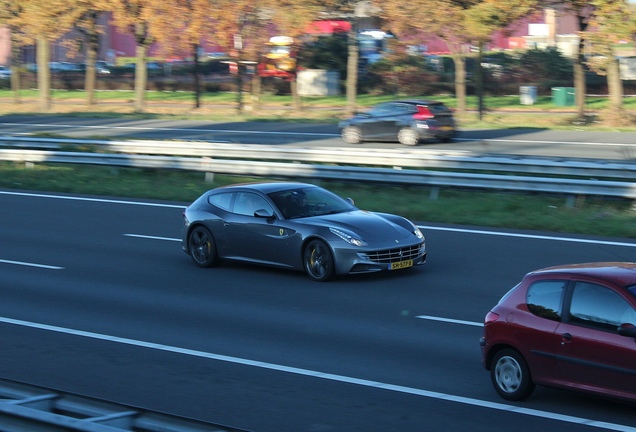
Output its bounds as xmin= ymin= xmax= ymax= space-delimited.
xmin=339 ymin=100 xmax=455 ymax=145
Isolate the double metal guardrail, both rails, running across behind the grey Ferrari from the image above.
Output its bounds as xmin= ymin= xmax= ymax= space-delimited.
xmin=0 ymin=137 xmax=636 ymax=199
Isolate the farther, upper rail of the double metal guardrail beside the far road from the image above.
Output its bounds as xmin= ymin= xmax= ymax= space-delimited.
xmin=0 ymin=136 xmax=636 ymax=180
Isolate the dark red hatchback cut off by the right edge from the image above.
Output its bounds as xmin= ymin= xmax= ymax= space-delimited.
xmin=479 ymin=262 xmax=636 ymax=402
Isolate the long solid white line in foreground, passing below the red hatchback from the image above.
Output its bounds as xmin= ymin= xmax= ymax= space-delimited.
xmin=0 ymin=317 xmax=636 ymax=431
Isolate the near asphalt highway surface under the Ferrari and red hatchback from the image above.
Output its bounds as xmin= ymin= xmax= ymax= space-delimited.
xmin=0 ymin=191 xmax=636 ymax=432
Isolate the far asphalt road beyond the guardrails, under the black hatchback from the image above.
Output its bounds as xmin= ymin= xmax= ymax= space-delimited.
xmin=0 ymin=114 xmax=636 ymax=160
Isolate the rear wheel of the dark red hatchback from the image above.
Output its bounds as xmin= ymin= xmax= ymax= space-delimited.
xmin=490 ymin=348 xmax=535 ymax=401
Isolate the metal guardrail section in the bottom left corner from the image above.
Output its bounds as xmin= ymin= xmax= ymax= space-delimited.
xmin=0 ymin=379 xmax=246 ymax=432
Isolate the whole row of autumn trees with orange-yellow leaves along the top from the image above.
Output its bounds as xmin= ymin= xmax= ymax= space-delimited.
xmin=0 ymin=0 xmax=636 ymax=121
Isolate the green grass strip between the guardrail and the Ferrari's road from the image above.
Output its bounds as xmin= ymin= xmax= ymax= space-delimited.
xmin=0 ymin=162 xmax=636 ymax=238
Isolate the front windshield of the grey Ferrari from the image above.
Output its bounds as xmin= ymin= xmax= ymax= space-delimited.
xmin=269 ymin=187 xmax=356 ymax=219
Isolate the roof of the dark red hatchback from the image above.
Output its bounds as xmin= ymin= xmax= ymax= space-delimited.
xmin=529 ymin=262 xmax=636 ymax=287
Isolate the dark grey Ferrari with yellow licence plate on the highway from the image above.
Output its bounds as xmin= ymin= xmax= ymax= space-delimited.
xmin=182 ymin=182 xmax=426 ymax=281
